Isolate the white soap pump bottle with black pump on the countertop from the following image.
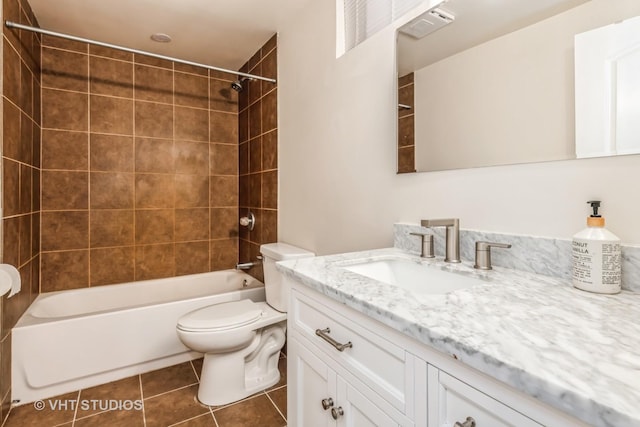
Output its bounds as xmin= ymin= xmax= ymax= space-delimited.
xmin=571 ymin=200 xmax=622 ymax=294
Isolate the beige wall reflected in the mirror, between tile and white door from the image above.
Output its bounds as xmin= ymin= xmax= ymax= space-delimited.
xmin=415 ymin=8 xmax=581 ymax=171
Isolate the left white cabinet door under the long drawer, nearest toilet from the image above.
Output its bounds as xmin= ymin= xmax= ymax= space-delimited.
xmin=287 ymin=337 xmax=338 ymax=427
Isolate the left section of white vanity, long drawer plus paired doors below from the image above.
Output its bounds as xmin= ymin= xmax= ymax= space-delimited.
xmin=287 ymin=290 xmax=415 ymax=427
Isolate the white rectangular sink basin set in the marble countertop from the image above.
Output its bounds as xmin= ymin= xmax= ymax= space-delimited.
xmin=341 ymin=258 xmax=487 ymax=295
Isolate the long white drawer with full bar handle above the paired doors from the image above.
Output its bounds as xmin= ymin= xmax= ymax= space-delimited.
xmin=289 ymin=290 xmax=413 ymax=412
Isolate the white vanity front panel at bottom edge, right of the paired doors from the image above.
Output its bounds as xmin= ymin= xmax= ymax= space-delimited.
xmin=428 ymin=366 xmax=542 ymax=427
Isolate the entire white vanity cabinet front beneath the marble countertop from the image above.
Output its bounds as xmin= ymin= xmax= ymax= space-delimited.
xmin=287 ymin=279 xmax=587 ymax=427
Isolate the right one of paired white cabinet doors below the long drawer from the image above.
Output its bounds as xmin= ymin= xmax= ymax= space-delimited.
xmin=335 ymin=377 xmax=404 ymax=427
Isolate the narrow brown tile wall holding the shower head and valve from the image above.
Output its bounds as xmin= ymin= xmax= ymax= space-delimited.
xmin=238 ymin=35 xmax=278 ymax=280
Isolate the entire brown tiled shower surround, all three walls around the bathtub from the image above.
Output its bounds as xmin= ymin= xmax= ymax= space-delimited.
xmin=0 ymin=0 xmax=277 ymax=420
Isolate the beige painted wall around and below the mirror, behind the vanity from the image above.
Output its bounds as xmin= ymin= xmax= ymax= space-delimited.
xmin=278 ymin=0 xmax=640 ymax=254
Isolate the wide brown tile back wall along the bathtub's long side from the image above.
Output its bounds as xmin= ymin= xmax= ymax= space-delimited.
xmin=41 ymin=36 xmax=239 ymax=292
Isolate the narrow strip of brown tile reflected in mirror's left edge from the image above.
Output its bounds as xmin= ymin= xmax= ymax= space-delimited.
xmin=398 ymin=73 xmax=416 ymax=173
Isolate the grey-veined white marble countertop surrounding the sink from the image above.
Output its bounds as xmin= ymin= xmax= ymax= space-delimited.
xmin=278 ymin=248 xmax=640 ymax=427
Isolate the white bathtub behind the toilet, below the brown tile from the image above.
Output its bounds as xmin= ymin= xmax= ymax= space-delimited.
xmin=11 ymin=270 xmax=265 ymax=405
